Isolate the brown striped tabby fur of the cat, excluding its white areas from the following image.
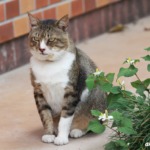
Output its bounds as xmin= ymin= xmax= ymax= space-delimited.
xmin=29 ymin=14 xmax=106 ymax=144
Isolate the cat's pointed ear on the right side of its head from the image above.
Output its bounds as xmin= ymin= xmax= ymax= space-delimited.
xmin=56 ymin=15 xmax=69 ymax=31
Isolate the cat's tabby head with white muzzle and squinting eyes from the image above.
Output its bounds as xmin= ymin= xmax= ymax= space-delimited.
xmin=28 ymin=14 xmax=69 ymax=61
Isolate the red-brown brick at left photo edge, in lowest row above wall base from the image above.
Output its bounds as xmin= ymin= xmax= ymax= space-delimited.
xmin=0 ymin=23 xmax=14 ymax=43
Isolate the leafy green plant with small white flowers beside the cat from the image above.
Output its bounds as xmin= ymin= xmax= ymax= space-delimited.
xmin=86 ymin=47 xmax=150 ymax=150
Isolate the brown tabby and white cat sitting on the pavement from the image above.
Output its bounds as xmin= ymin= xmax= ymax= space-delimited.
xmin=28 ymin=13 xmax=106 ymax=145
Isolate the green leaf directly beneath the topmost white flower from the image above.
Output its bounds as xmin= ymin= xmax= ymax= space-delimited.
xmin=117 ymin=65 xmax=138 ymax=78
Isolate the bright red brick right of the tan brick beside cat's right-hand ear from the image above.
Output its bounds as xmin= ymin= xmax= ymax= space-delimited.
xmin=71 ymin=0 xmax=83 ymax=17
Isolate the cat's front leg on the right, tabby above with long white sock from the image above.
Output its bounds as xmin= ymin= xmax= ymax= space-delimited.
xmin=54 ymin=87 xmax=79 ymax=145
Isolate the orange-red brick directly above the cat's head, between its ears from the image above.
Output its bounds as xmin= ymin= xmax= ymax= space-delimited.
xmin=44 ymin=8 xmax=56 ymax=19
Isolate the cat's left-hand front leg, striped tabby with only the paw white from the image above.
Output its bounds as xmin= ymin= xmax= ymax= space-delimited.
xmin=34 ymin=85 xmax=55 ymax=143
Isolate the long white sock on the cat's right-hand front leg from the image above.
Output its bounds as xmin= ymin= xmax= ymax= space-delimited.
xmin=54 ymin=116 xmax=74 ymax=145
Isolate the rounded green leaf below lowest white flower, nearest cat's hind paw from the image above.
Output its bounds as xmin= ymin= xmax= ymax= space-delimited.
xmin=87 ymin=120 xmax=105 ymax=134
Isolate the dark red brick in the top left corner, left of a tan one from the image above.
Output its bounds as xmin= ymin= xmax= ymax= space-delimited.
xmin=6 ymin=0 xmax=19 ymax=19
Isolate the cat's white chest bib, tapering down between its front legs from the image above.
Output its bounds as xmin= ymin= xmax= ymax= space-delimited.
xmin=30 ymin=52 xmax=75 ymax=114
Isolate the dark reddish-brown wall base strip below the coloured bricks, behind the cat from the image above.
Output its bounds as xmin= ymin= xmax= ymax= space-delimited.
xmin=0 ymin=0 xmax=150 ymax=74
